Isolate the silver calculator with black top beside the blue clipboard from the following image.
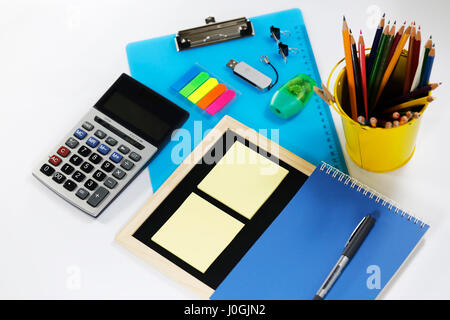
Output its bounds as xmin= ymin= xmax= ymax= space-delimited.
xmin=33 ymin=74 xmax=189 ymax=217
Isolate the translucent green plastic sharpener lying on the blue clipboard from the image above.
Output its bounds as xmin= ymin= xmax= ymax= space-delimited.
xmin=270 ymin=73 xmax=317 ymax=119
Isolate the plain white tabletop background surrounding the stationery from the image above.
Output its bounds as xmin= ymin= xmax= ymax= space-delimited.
xmin=0 ymin=0 xmax=450 ymax=299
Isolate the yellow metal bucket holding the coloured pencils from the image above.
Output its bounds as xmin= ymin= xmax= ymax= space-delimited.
xmin=327 ymin=50 xmax=428 ymax=172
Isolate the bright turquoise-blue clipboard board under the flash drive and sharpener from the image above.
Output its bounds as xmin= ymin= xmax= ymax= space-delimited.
xmin=126 ymin=9 xmax=347 ymax=191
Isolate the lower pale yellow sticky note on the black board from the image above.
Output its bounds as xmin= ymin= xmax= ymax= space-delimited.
xmin=152 ymin=193 xmax=244 ymax=273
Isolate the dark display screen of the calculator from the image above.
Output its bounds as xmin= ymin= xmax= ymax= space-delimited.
xmin=102 ymin=92 xmax=170 ymax=141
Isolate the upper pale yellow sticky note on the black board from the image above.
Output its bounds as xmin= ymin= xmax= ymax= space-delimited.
xmin=198 ymin=141 xmax=289 ymax=219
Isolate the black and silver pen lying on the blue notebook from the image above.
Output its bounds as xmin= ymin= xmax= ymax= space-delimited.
xmin=313 ymin=216 xmax=375 ymax=300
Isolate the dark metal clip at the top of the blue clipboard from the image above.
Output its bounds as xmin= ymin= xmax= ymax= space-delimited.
xmin=175 ymin=17 xmax=255 ymax=51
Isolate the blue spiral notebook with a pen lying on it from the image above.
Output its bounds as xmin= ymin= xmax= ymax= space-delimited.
xmin=211 ymin=164 xmax=429 ymax=300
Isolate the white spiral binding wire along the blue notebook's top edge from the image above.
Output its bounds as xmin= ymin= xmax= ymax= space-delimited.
xmin=320 ymin=161 xmax=425 ymax=228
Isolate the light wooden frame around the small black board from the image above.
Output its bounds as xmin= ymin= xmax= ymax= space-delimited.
xmin=115 ymin=116 xmax=315 ymax=299
